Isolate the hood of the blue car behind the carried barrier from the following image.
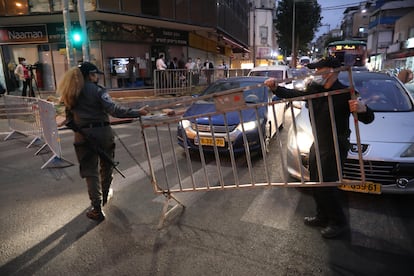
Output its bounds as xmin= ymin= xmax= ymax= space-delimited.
xmin=183 ymin=103 xmax=263 ymax=126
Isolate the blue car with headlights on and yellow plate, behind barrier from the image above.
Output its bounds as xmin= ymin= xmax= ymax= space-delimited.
xmin=177 ymin=77 xmax=286 ymax=153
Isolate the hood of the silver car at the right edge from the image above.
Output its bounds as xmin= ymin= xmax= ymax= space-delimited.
xmin=349 ymin=111 xmax=414 ymax=143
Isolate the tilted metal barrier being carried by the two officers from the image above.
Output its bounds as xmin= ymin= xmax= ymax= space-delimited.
xmin=141 ymin=66 xmax=365 ymax=227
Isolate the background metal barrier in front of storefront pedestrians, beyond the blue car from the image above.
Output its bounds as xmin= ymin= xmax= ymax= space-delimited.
xmin=154 ymin=69 xmax=249 ymax=96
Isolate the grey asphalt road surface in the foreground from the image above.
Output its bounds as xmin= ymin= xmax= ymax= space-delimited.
xmin=0 ymin=110 xmax=414 ymax=275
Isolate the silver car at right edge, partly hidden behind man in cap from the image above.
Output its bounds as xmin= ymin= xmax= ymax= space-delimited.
xmin=287 ymin=71 xmax=414 ymax=194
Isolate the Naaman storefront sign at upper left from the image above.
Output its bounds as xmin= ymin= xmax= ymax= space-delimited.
xmin=0 ymin=25 xmax=48 ymax=44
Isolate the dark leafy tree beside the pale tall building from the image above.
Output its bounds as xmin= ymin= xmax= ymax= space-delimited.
xmin=275 ymin=0 xmax=322 ymax=56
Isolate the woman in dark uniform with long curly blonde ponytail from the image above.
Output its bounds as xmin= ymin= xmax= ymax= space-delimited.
xmin=57 ymin=62 xmax=148 ymax=221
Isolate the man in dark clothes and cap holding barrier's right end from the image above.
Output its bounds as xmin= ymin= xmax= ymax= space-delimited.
xmin=265 ymin=56 xmax=374 ymax=238
